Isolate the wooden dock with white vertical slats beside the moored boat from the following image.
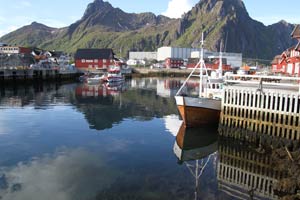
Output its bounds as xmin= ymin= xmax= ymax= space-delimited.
xmin=220 ymin=75 xmax=300 ymax=140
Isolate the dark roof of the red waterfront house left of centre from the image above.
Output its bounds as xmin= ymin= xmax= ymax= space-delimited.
xmin=75 ymin=49 xmax=115 ymax=59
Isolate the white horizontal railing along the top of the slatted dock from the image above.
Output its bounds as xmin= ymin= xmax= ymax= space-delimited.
xmin=225 ymin=74 xmax=300 ymax=93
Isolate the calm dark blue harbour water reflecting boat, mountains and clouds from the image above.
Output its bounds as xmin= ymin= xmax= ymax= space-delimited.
xmin=0 ymin=78 xmax=298 ymax=200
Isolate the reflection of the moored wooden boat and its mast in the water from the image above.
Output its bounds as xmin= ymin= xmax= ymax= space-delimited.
xmin=173 ymin=123 xmax=218 ymax=200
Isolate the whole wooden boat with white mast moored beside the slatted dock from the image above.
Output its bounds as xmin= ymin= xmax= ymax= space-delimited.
xmin=175 ymin=34 xmax=223 ymax=127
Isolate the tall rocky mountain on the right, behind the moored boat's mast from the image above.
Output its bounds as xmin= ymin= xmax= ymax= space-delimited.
xmin=175 ymin=0 xmax=295 ymax=59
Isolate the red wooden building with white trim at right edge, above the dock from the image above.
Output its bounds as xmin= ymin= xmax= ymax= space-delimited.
xmin=272 ymin=25 xmax=300 ymax=77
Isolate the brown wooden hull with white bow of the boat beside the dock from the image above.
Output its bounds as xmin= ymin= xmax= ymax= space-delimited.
xmin=175 ymin=96 xmax=221 ymax=127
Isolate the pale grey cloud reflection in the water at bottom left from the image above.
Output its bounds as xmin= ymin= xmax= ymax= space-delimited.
xmin=0 ymin=149 xmax=121 ymax=200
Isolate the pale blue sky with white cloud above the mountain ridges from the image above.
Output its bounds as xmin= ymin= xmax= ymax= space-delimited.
xmin=0 ymin=0 xmax=300 ymax=36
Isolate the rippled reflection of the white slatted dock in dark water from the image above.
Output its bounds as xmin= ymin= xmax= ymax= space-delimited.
xmin=217 ymin=141 xmax=284 ymax=199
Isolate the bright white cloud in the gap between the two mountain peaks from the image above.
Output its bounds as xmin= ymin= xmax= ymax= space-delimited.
xmin=162 ymin=0 xmax=193 ymax=18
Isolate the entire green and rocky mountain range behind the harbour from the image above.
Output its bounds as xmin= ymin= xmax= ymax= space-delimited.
xmin=0 ymin=0 xmax=295 ymax=59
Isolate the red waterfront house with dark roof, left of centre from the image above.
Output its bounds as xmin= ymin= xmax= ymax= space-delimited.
xmin=75 ymin=49 xmax=115 ymax=71
